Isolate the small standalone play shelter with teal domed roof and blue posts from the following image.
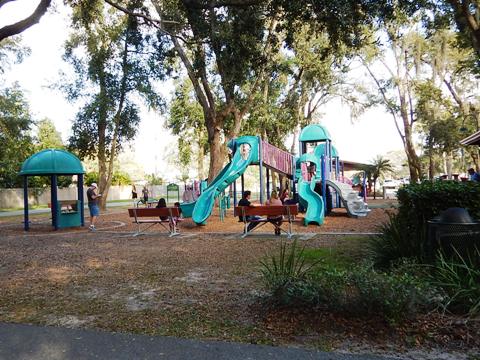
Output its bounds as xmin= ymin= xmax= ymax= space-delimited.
xmin=20 ymin=149 xmax=85 ymax=231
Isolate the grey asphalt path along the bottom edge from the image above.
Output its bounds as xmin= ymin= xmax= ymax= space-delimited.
xmin=0 ymin=323 xmax=393 ymax=360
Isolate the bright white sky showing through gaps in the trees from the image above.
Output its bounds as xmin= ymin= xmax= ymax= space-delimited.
xmin=0 ymin=0 xmax=402 ymax=180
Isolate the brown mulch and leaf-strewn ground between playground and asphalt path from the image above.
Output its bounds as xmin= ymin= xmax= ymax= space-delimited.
xmin=0 ymin=201 xmax=480 ymax=359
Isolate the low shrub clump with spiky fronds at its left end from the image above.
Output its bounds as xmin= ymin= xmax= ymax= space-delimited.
xmin=261 ymin=243 xmax=438 ymax=321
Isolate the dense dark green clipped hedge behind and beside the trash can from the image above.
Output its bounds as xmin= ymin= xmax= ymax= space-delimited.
xmin=369 ymin=181 xmax=480 ymax=266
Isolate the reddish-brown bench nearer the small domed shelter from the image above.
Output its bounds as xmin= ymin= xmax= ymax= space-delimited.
xmin=128 ymin=207 xmax=181 ymax=236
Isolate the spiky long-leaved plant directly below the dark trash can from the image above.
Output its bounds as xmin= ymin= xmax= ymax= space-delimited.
xmin=431 ymin=248 xmax=480 ymax=315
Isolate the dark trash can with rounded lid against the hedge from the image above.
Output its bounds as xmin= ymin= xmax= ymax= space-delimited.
xmin=428 ymin=208 xmax=480 ymax=258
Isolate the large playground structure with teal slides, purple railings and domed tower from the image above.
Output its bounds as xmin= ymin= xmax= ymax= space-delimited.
xmin=181 ymin=124 xmax=370 ymax=225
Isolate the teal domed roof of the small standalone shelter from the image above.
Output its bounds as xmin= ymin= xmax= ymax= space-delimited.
xmin=20 ymin=149 xmax=85 ymax=176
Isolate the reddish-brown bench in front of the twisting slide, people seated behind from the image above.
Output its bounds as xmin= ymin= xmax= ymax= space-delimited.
xmin=234 ymin=205 xmax=298 ymax=238
